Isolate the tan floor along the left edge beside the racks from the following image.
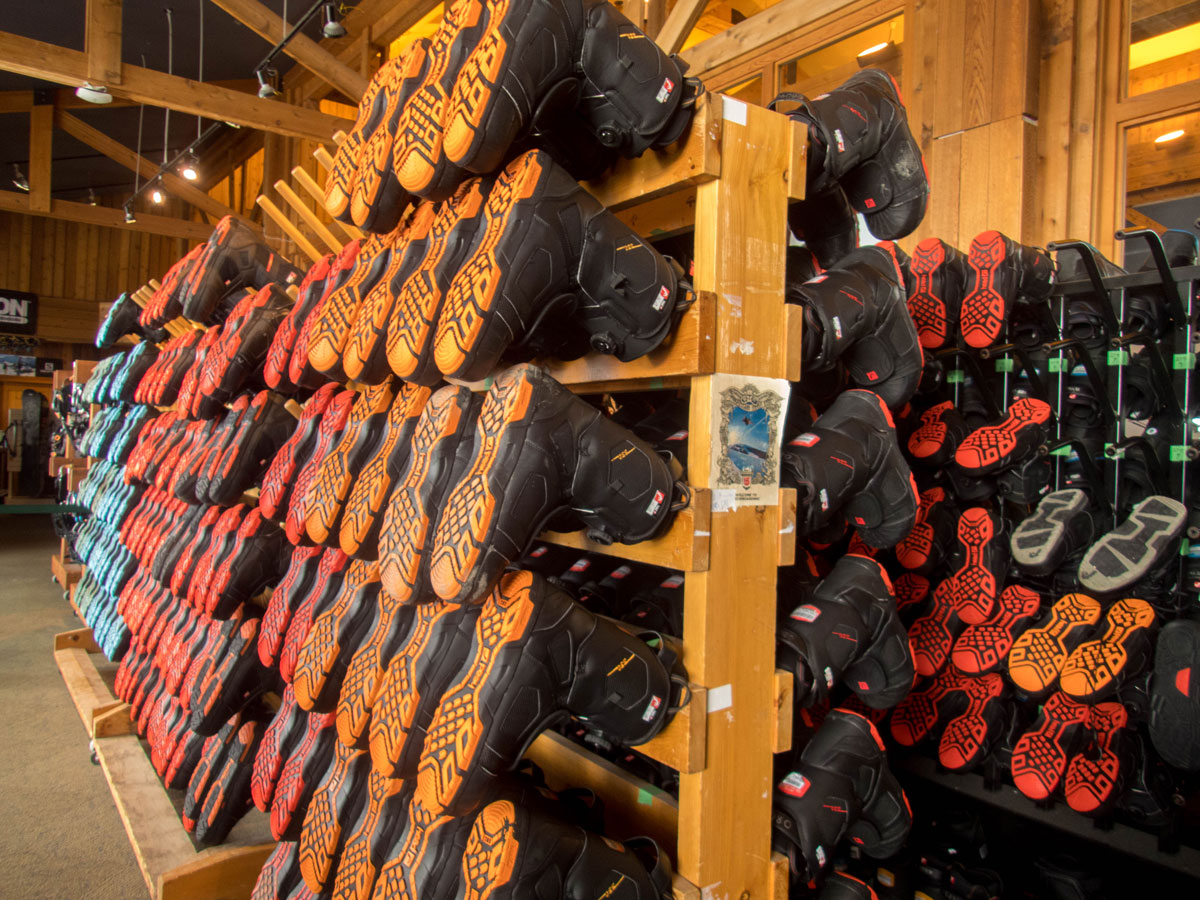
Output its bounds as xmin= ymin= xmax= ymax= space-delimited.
xmin=0 ymin=515 xmax=148 ymax=900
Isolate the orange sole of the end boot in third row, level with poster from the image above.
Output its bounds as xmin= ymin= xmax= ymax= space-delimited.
xmin=430 ymin=367 xmax=540 ymax=602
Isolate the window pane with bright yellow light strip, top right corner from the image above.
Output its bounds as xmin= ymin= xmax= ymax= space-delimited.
xmin=1128 ymin=0 xmax=1200 ymax=96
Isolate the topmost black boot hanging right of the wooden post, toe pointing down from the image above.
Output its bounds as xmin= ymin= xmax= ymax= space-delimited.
xmin=776 ymin=68 xmax=929 ymax=240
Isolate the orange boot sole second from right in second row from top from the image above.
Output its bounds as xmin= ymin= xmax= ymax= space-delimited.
xmin=388 ymin=179 xmax=490 ymax=383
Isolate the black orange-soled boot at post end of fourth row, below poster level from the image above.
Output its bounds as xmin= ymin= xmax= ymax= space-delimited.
xmin=416 ymin=572 xmax=684 ymax=815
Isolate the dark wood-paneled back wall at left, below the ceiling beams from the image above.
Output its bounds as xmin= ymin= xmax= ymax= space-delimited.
xmin=0 ymin=212 xmax=187 ymax=348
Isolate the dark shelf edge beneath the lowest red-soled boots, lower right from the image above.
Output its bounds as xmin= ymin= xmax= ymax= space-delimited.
xmin=892 ymin=756 xmax=1200 ymax=878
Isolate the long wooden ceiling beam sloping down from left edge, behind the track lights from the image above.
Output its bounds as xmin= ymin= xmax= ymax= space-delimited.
xmin=0 ymin=31 xmax=350 ymax=144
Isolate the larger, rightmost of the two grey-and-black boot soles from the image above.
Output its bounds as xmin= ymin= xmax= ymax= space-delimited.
xmin=1079 ymin=497 xmax=1188 ymax=595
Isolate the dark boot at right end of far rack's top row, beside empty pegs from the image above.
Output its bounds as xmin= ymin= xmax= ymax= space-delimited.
xmin=180 ymin=216 xmax=301 ymax=324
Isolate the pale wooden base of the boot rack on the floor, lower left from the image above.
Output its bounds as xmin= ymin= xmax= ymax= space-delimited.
xmin=54 ymin=628 xmax=275 ymax=900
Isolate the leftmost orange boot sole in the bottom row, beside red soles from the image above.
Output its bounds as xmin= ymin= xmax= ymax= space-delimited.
xmin=299 ymin=749 xmax=366 ymax=894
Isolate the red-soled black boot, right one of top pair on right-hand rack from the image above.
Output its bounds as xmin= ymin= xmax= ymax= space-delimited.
xmin=960 ymin=232 xmax=1055 ymax=349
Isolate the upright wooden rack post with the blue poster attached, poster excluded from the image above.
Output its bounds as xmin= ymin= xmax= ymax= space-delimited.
xmin=677 ymin=97 xmax=792 ymax=898
